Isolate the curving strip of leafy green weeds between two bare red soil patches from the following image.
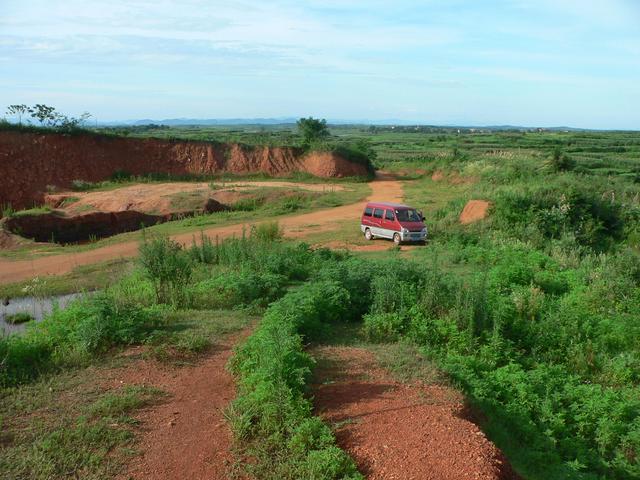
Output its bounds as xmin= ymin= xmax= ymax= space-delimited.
xmin=228 ymin=283 xmax=363 ymax=479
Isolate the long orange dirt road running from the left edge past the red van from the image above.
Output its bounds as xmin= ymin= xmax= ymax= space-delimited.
xmin=0 ymin=176 xmax=402 ymax=284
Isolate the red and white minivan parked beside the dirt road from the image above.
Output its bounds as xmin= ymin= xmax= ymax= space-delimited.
xmin=360 ymin=202 xmax=427 ymax=244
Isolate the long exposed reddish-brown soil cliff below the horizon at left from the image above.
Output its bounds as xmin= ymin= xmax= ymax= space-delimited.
xmin=0 ymin=132 xmax=367 ymax=208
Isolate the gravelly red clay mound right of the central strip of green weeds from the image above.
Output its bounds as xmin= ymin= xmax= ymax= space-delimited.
xmin=313 ymin=347 xmax=519 ymax=480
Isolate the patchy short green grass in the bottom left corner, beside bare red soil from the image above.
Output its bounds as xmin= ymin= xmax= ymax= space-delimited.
xmin=0 ymin=367 xmax=163 ymax=480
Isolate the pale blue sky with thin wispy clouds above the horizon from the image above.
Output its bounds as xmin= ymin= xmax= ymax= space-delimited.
xmin=0 ymin=0 xmax=640 ymax=129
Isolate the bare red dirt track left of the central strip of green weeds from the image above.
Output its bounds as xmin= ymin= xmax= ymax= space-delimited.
xmin=104 ymin=330 xmax=250 ymax=480
